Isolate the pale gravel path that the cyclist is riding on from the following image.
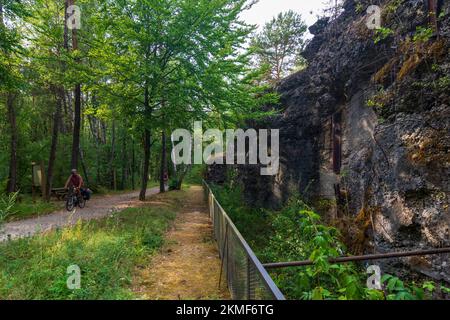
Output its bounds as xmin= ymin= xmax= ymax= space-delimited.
xmin=0 ymin=188 xmax=159 ymax=242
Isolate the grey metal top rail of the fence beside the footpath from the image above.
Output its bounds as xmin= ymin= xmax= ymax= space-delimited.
xmin=203 ymin=181 xmax=285 ymax=300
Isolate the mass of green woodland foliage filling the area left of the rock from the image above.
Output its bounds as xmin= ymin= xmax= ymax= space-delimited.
xmin=0 ymin=0 xmax=278 ymax=202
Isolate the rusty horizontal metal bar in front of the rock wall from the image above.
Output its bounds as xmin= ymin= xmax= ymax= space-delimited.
xmin=263 ymin=247 xmax=450 ymax=269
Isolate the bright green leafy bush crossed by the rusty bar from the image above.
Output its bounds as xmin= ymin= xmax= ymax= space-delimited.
xmin=264 ymin=197 xmax=365 ymax=300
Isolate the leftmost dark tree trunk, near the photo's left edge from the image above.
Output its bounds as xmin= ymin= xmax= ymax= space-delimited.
xmin=6 ymin=94 xmax=19 ymax=193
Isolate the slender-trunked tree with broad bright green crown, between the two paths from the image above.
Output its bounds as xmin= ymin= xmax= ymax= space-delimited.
xmin=96 ymin=0 xmax=274 ymax=200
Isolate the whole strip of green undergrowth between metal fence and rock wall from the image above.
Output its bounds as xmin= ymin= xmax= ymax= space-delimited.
xmin=213 ymin=185 xmax=449 ymax=300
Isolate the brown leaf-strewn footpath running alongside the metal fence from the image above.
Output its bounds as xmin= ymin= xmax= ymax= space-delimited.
xmin=133 ymin=187 xmax=230 ymax=300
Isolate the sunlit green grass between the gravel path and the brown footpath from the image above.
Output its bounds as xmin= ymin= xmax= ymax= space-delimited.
xmin=0 ymin=191 xmax=185 ymax=300
